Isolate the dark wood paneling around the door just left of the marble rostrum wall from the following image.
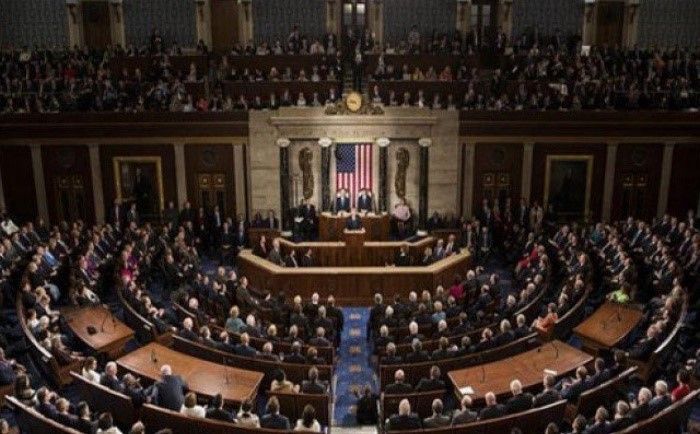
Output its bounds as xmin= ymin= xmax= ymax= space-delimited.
xmin=185 ymin=145 xmax=236 ymax=216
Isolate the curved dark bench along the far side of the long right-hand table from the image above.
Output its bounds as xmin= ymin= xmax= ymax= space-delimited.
xmin=379 ymin=333 xmax=540 ymax=390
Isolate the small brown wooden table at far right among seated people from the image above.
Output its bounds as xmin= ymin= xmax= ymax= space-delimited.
xmin=574 ymin=302 xmax=643 ymax=353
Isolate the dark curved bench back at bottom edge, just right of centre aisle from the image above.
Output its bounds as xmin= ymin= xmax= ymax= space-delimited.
xmin=388 ymin=400 xmax=566 ymax=434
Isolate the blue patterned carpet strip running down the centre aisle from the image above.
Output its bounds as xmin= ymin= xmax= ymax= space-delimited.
xmin=333 ymin=307 xmax=376 ymax=426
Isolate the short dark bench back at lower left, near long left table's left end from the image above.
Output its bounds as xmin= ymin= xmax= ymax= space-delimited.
xmin=70 ymin=372 xmax=138 ymax=427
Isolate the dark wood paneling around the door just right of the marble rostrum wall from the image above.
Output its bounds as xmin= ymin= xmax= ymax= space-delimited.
xmin=472 ymin=143 xmax=523 ymax=210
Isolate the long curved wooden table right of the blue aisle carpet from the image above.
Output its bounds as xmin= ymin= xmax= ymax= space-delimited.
xmin=447 ymin=341 xmax=593 ymax=401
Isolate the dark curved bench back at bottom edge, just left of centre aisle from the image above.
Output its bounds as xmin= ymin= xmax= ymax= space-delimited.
xmin=141 ymin=404 xmax=296 ymax=434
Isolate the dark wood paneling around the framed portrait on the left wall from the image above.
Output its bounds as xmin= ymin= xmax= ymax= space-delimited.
xmin=100 ymin=144 xmax=177 ymax=220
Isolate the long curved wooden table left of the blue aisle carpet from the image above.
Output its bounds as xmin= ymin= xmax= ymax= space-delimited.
xmin=117 ymin=343 xmax=264 ymax=405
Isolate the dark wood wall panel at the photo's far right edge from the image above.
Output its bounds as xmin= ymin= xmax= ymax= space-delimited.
xmin=659 ymin=143 xmax=700 ymax=216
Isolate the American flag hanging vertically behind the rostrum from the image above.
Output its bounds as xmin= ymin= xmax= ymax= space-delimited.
xmin=335 ymin=143 xmax=372 ymax=206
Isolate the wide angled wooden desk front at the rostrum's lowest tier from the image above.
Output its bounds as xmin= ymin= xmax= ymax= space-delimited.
xmin=238 ymin=248 xmax=471 ymax=306
